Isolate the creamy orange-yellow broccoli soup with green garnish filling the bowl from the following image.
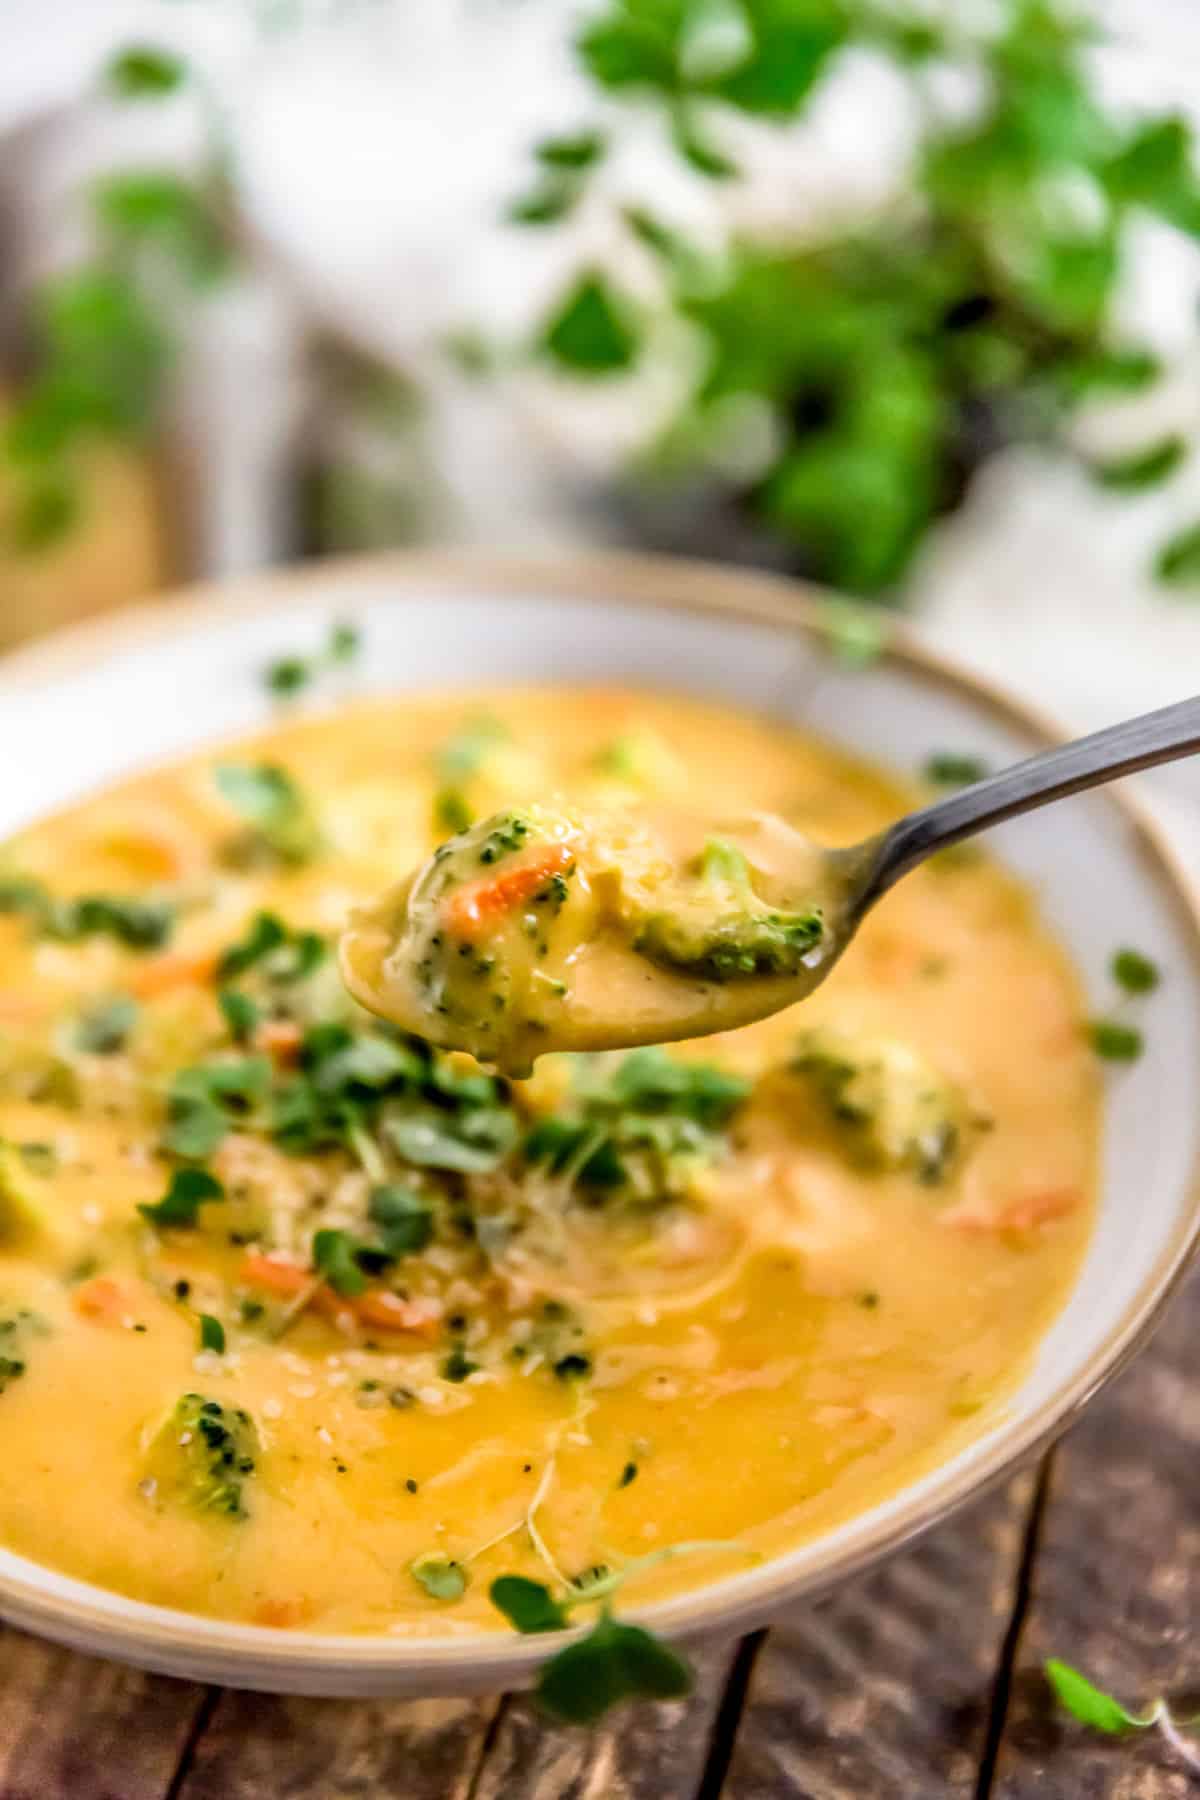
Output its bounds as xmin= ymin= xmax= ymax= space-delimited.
xmin=0 ymin=689 xmax=1097 ymax=1634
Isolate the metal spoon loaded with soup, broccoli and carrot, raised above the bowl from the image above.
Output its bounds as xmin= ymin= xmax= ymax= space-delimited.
xmin=340 ymin=697 xmax=1200 ymax=1075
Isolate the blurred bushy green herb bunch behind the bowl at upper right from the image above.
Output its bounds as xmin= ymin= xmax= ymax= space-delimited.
xmin=515 ymin=0 xmax=1200 ymax=594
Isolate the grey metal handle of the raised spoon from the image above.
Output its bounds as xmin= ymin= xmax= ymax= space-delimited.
xmin=862 ymin=695 xmax=1200 ymax=909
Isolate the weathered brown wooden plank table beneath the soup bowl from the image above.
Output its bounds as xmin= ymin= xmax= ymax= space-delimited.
xmin=0 ymin=1245 xmax=1200 ymax=1800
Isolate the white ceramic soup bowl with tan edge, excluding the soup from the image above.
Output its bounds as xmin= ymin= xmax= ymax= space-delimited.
xmin=0 ymin=556 xmax=1200 ymax=1696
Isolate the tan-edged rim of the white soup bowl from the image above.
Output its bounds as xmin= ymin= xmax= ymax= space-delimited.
xmin=0 ymin=551 xmax=1200 ymax=1694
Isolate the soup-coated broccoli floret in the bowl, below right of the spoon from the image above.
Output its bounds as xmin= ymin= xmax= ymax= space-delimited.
xmin=788 ymin=1030 xmax=981 ymax=1188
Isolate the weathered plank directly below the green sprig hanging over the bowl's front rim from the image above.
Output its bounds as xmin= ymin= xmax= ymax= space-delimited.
xmin=471 ymin=1645 xmax=736 ymax=1800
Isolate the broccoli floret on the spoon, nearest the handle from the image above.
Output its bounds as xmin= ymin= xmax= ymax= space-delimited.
xmin=633 ymin=909 xmax=824 ymax=981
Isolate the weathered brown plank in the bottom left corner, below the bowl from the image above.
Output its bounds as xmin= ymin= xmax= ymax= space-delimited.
xmin=0 ymin=1627 xmax=207 ymax=1800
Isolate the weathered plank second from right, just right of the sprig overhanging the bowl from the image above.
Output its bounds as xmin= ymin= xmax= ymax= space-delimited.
xmin=723 ymin=1476 xmax=1033 ymax=1800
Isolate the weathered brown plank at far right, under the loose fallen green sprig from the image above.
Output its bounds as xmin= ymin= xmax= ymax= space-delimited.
xmin=993 ymin=1278 xmax=1200 ymax=1800
